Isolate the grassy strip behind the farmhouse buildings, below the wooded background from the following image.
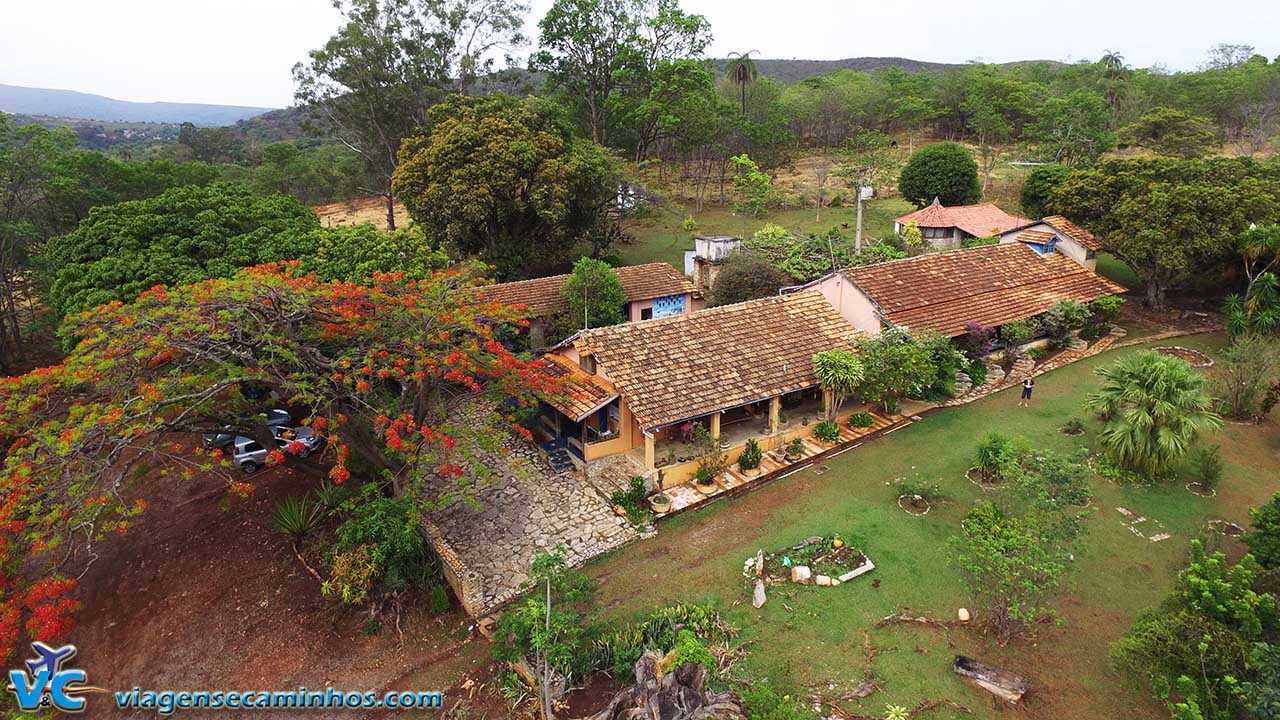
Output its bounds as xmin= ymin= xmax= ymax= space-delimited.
xmin=614 ymin=199 xmax=911 ymax=269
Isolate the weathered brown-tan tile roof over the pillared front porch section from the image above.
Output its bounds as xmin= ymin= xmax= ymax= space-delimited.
xmin=573 ymin=291 xmax=855 ymax=429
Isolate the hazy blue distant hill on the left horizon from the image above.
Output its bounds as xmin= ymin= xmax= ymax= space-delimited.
xmin=0 ymin=85 xmax=271 ymax=127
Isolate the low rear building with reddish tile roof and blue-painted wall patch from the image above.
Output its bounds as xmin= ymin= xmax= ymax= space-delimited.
xmin=472 ymin=263 xmax=704 ymax=347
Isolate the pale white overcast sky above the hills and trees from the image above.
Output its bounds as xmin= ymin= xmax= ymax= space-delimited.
xmin=0 ymin=0 xmax=1280 ymax=108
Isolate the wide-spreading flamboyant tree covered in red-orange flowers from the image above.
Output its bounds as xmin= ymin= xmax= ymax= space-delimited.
xmin=0 ymin=264 xmax=554 ymax=657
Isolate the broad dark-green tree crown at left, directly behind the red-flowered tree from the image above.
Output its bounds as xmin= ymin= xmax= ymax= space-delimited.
xmin=42 ymin=183 xmax=320 ymax=315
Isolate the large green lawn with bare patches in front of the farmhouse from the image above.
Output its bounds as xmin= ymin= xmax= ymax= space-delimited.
xmin=588 ymin=336 xmax=1280 ymax=719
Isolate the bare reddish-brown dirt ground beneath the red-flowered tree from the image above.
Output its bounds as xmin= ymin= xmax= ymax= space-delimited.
xmin=72 ymin=456 xmax=490 ymax=717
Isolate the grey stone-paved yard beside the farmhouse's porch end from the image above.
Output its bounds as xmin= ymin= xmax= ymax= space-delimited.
xmin=424 ymin=399 xmax=639 ymax=618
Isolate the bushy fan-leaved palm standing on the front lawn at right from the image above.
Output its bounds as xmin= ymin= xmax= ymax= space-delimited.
xmin=1084 ymin=351 xmax=1222 ymax=478
